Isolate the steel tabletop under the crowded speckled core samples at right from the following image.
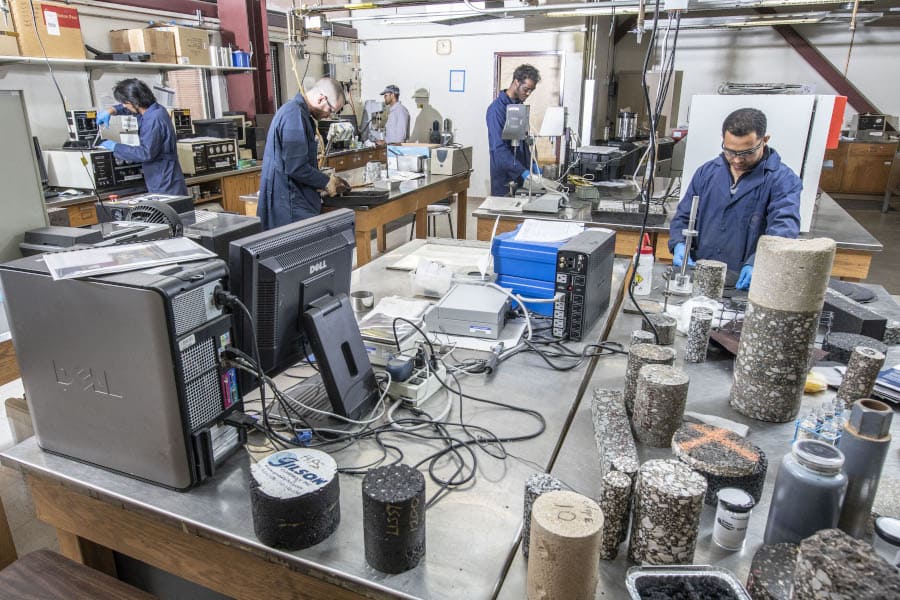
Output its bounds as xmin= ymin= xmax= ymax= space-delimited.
xmin=498 ymin=265 xmax=900 ymax=600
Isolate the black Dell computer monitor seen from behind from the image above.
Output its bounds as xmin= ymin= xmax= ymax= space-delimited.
xmin=228 ymin=209 xmax=378 ymax=418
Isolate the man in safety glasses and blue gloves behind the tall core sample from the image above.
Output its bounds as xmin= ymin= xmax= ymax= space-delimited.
xmin=669 ymin=108 xmax=803 ymax=290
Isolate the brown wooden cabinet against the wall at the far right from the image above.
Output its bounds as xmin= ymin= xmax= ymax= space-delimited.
xmin=819 ymin=142 xmax=897 ymax=195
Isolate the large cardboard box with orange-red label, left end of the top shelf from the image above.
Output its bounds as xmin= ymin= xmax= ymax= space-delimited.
xmin=9 ymin=0 xmax=85 ymax=59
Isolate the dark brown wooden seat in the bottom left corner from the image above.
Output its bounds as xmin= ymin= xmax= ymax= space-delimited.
xmin=0 ymin=550 xmax=154 ymax=600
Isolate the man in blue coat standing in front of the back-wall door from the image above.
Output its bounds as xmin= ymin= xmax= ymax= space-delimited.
xmin=486 ymin=65 xmax=541 ymax=196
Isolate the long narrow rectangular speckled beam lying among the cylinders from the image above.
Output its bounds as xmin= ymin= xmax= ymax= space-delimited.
xmin=591 ymin=388 xmax=640 ymax=481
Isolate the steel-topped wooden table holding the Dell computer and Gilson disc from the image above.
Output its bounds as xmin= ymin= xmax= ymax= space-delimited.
xmin=0 ymin=240 xmax=628 ymax=598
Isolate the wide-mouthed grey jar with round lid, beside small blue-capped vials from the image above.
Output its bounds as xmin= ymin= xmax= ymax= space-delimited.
xmin=763 ymin=440 xmax=847 ymax=544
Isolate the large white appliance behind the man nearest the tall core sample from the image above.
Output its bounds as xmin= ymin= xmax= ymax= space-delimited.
xmin=682 ymin=94 xmax=834 ymax=232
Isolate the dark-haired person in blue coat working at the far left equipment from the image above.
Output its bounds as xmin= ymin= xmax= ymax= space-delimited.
xmin=97 ymin=79 xmax=187 ymax=196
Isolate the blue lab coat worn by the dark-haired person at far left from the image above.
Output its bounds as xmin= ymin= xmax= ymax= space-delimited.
xmin=113 ymin=102 xmax=187 ymax=196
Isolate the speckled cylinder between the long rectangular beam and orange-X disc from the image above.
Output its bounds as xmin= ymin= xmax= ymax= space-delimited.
xmin=631 ymin=365 xmax=690 ymax=448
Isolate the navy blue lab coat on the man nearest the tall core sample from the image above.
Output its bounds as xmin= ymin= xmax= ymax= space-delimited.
xmin=669 ymin=148 xmax=803 ymax=271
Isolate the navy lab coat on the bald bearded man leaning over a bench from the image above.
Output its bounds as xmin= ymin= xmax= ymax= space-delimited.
xmin=256 ymin=93 xmax=329 ymax=229
